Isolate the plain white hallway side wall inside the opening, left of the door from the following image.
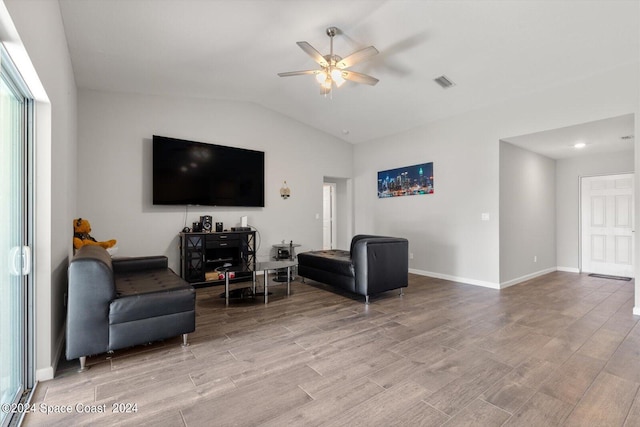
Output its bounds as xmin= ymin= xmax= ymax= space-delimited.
xmin=500 ymin=142 xmax=556 ymax=288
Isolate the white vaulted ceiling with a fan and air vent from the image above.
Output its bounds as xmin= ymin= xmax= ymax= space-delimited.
xmin=60 ymin=0 xmax=640 ymax=147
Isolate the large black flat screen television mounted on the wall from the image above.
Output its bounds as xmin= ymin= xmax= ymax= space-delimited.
xmin=153 ymin=135 xmax=264 ymax=207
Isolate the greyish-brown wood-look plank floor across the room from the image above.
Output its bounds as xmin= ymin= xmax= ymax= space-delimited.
xmin=25 ymin=272 xmax=640 ymax=426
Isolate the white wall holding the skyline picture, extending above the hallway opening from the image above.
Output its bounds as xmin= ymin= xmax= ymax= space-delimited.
xmin=354 ymin=63 xmax=640 ymax=288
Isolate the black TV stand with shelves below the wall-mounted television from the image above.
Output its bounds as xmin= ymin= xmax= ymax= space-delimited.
xmin=180 ymin=231 xmax=256 ymax=287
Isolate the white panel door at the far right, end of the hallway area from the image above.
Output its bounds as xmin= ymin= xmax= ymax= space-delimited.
xmin=581 ymin=174 xmax=634 ymax=277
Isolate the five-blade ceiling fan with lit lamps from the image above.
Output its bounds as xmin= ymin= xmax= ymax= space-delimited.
xmin=278 ymin=27 xmax=378 ymax=95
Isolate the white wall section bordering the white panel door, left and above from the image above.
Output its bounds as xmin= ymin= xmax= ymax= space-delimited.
xmin=556 ymin=150 xmax=637 ymax=272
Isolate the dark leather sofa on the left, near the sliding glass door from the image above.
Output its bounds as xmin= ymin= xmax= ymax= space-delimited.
xmin=66 ymin=246 xmax=195 ymax=371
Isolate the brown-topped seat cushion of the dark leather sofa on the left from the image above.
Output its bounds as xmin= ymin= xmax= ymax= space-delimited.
xmin=109 ymin=268 xmax=195 ymax=325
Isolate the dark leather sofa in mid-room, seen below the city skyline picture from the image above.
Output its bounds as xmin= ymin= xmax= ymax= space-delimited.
xmin=298 ymin=234 xmax=409 ymax=303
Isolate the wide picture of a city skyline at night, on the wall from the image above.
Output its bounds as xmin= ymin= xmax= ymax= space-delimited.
xmin=378 ymin=162 xmax=434 ymax=199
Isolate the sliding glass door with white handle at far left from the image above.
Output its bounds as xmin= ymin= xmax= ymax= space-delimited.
xmin=0 ymin=46 xmax=32 ymax=426
